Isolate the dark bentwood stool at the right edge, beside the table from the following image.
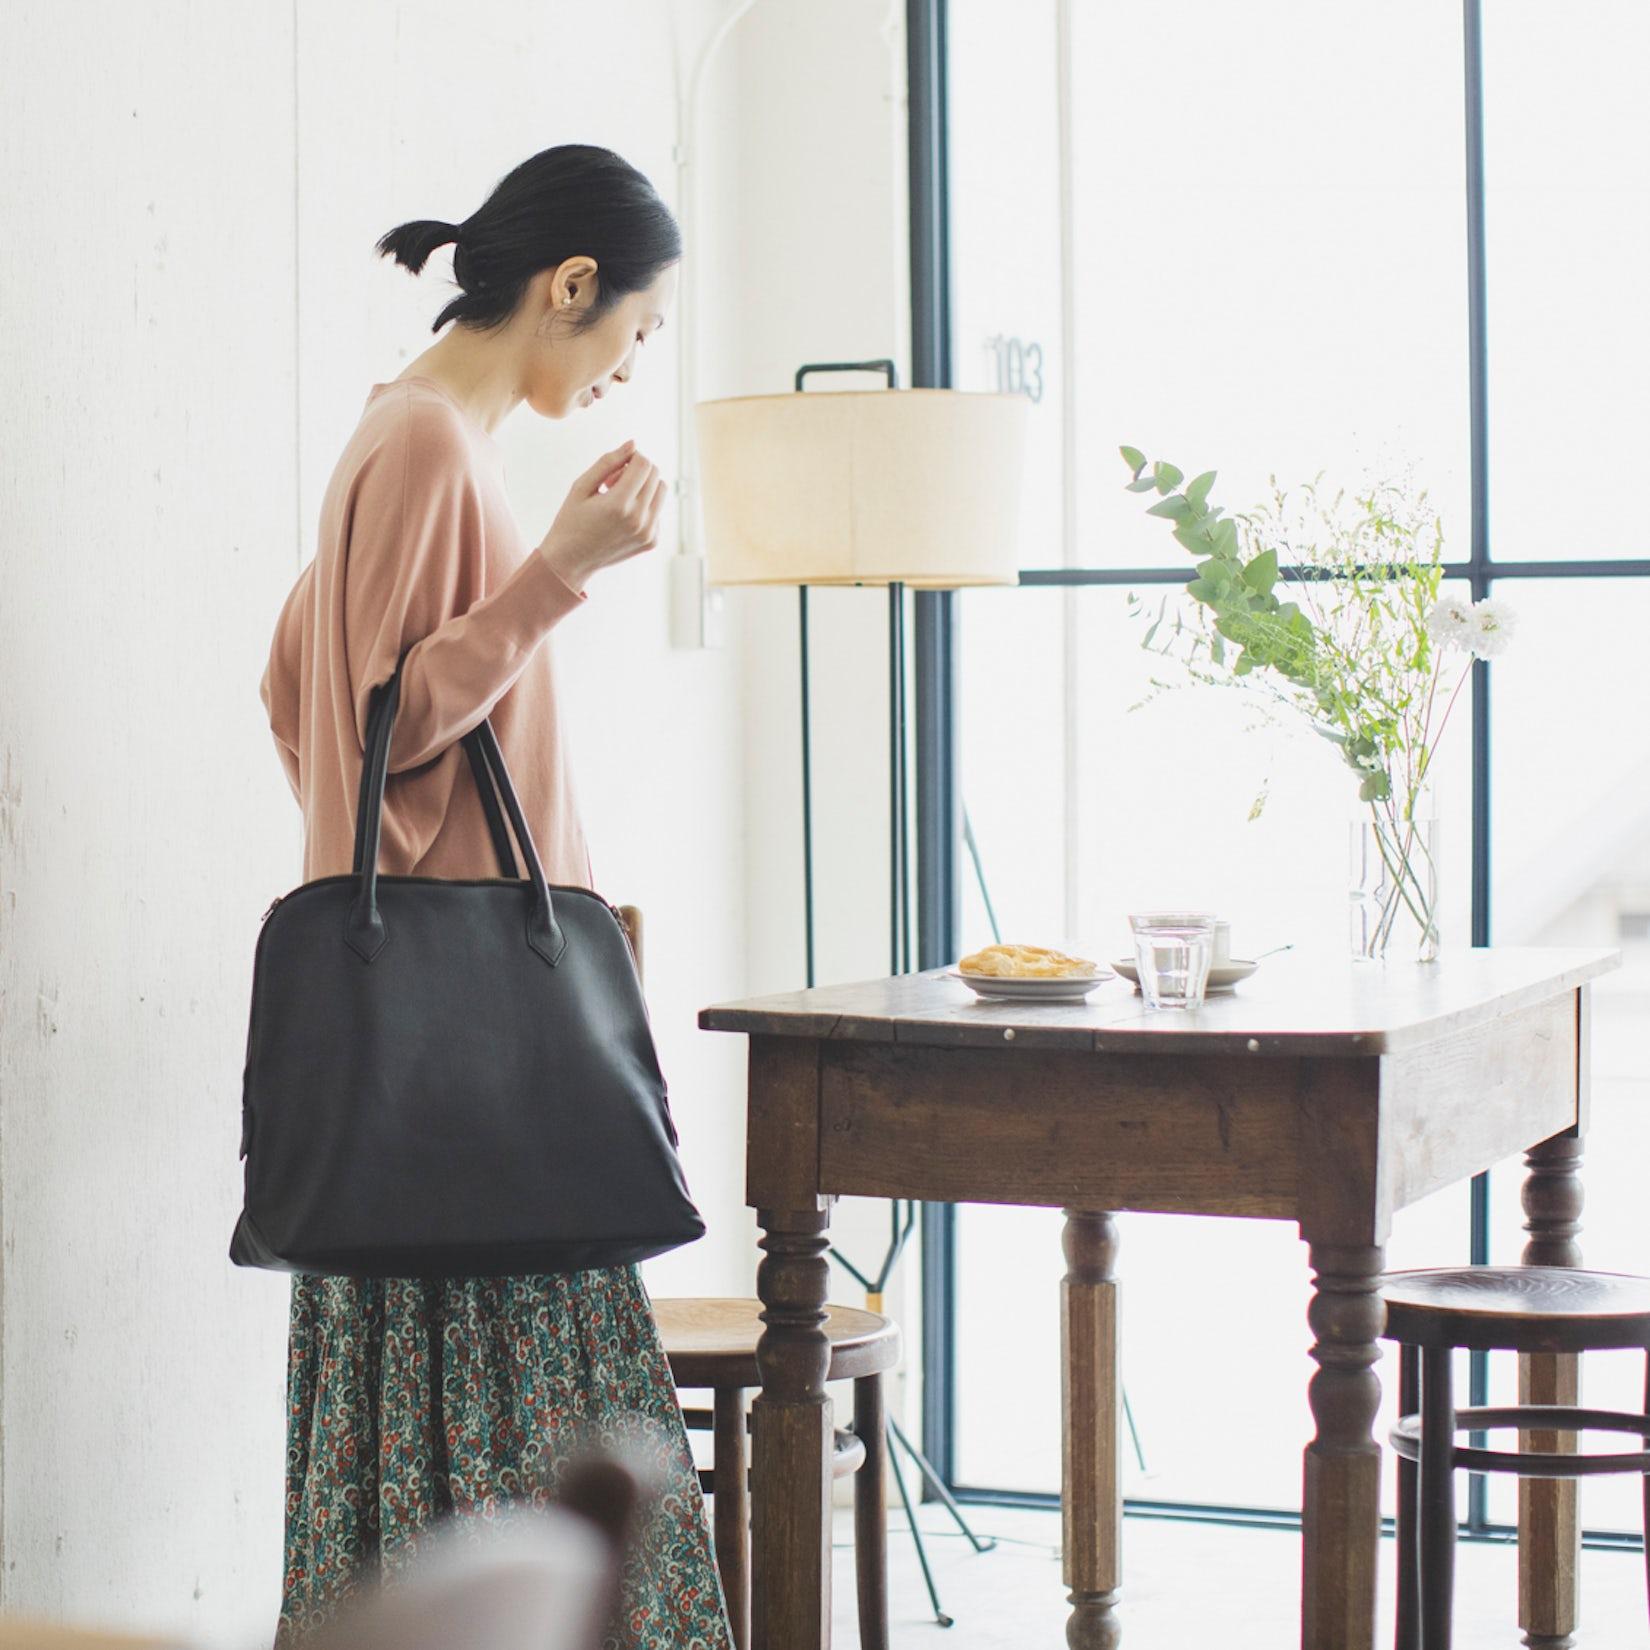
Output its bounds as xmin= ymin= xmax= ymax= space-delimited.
xmin=1381 ymin=1266 xmax=1650 ymax=1650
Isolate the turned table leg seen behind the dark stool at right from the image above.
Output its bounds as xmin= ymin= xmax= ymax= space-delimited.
xmin=1518 ymin=1134 xmax=1582 ymax=1650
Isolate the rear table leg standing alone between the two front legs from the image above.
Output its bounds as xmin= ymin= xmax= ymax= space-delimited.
xmin=1059 ymin=1209 xmax=1122 ymax=1650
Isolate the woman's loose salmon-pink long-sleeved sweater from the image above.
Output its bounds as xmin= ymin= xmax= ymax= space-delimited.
xmin=259 ymin=378 xmax=594 ymax=888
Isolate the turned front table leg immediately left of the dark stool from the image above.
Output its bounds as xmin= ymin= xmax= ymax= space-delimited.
xmin=1300 ymin=1242 xmax=1386 ymax=1650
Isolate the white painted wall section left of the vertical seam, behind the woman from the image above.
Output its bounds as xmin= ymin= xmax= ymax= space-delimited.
xmin=0 ymin=3 xmax=301 ymax=1630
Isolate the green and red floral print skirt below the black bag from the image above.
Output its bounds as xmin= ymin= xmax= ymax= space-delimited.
xmin=276 ymin=1266 xmax=733 ymax=1650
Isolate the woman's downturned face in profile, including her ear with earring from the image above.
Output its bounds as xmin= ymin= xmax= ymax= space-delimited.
xmin=528 ymin=257 xmax=677 ymax=417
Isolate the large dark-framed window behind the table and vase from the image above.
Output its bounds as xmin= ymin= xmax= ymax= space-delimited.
xmin=927 ymin=0 xmax=1650 ymax=1530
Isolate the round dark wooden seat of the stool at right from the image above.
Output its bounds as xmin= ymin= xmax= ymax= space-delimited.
xmin=1381 ymin=1266 xmax=1650 ymax=1351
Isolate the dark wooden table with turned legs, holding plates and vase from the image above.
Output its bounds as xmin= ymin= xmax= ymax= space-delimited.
xmin=700 ymin=947 xmax=1620 ymax=1650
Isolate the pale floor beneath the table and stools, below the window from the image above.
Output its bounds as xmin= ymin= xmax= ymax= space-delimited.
xmin=833 ymin=1505 xmax=1650 ymax=1650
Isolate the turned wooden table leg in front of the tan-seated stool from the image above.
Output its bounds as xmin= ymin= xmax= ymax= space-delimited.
xmin=751 ymin=1209 xmax=832 ymax=1650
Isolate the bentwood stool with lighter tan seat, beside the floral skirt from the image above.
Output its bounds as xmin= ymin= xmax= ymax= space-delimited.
xmin=653 ymin=1300 xmax=899 ymax=1650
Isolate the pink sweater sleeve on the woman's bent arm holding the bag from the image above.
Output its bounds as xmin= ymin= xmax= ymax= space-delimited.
xmin=345 ymin=406 xmax=586 ymax=774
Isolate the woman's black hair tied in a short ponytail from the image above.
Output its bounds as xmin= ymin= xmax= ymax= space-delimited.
xmin=376 ymin=144 xmax=681 ymax=332
